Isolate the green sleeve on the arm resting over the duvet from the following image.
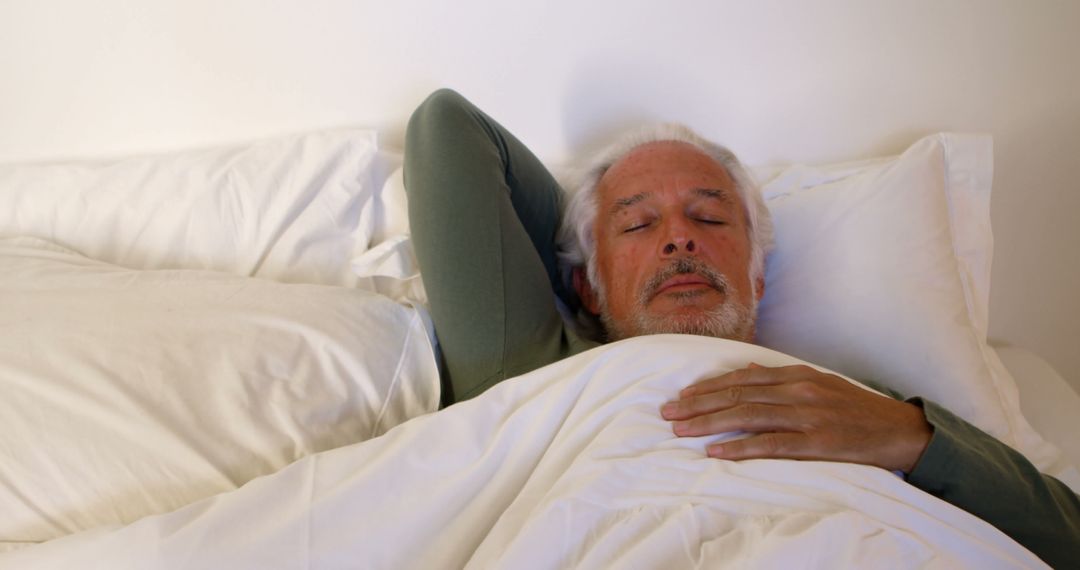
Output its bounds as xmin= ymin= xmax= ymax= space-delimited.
xmin=907 ymin=398 xmax=1080 ymax=568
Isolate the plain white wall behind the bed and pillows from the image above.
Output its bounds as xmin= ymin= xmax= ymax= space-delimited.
xmin=0 ymin=0 xmax=1080 ymax=389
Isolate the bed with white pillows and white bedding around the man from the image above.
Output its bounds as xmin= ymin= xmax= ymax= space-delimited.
xmin=0 ymin=128 xmax=1080 ymax=568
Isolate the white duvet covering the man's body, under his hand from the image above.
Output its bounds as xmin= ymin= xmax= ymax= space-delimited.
xmin=0 ymin=336 xmax=1043 ymax=569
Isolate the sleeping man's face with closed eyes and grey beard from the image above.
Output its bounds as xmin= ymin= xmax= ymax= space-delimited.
xmin=583 ymin=141 xmax=764 ymax=341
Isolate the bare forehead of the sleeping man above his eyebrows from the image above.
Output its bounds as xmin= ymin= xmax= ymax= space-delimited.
xmin=597 ymin=140 xmax=734 ymax=203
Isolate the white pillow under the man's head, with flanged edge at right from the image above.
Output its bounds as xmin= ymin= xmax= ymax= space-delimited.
xmin=757 ymin=134 xmax=1059 ymax=469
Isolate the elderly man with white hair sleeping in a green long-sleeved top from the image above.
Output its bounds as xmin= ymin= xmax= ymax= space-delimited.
xmin=405 ymin=90 xmax=1080 ymax=566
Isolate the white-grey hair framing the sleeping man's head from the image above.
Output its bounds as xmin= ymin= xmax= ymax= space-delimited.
xmin=557 ymin=123 xmax=773 ymax=334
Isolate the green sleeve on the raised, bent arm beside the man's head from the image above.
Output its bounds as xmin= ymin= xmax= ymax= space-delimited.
xmin=404 ymin=90 xmax=594 ymax=405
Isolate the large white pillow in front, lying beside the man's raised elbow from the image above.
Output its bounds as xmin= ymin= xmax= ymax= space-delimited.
xmin=0 ymin=238 xmax=438 ymax=544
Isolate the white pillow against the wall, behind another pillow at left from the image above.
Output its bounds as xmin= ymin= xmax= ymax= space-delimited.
xmin=0 ymin=130 xmax=377 ymax=286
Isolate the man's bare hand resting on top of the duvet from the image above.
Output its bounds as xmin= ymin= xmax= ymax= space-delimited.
xmin=661 ymin=364 xmax=932 ymax=473
